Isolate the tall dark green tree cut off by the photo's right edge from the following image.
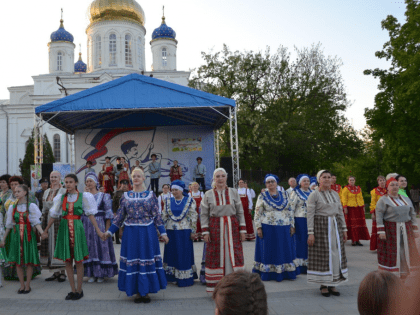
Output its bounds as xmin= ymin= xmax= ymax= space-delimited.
xmin=364 ymin=0 xmax=420 ymax=184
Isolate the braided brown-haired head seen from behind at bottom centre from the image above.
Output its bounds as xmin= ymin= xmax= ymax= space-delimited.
xmin=213 ymin=271 xmax=268 ymax=315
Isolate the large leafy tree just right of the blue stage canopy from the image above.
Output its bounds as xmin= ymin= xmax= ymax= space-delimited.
xmin=190 ymin=44 xmax=362 ymax=173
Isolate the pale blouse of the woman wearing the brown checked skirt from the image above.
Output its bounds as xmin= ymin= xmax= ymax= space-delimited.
xmin=306 ymin=190 xmax=347 ymax=234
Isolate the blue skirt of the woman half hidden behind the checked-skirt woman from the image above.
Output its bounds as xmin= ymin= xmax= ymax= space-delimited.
xmin=294 ymin=217 xmax=308 ymax=274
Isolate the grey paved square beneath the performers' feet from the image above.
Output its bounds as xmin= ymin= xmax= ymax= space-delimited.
xmin=0 ymin=220 xmax=377 ymax=315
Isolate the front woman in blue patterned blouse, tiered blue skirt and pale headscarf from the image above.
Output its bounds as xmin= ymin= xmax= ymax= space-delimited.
xmin=104 ymin=168 xmax=169 ymax=303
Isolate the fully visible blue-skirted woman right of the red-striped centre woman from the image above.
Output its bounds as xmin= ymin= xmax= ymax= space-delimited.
xmin=252 ymin=174 xmax=299 ymax=282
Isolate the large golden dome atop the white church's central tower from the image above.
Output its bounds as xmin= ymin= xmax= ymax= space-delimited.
xmin=88 ymin=0 xmax=146 ymax=26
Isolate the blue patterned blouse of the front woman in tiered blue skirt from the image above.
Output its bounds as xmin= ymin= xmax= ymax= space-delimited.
xmin=108 ymin=190 xmax=166 ymax=235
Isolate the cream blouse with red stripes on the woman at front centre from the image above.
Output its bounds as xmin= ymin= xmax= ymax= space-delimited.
xmin=200 ymin=188 xmax=246 ymax=235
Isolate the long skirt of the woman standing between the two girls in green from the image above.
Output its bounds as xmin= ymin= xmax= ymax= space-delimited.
xmin=40 ymin=210 xmax=66 ymax=272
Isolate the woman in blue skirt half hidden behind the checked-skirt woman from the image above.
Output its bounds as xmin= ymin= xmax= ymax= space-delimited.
xmin=290 ymin=174 xmax=312 ymax=274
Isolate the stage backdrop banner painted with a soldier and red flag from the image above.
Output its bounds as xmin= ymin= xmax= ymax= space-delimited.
xmin=75 ymin=126 xmax=214 ymax=193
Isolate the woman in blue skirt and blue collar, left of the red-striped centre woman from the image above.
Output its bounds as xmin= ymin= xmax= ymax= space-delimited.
xmin=162 ymin=180 xmax=198 ymax=287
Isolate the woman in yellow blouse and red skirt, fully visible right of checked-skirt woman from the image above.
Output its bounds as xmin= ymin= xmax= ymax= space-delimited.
xmin=341 ymin=176 xmax=370 ymax=246
